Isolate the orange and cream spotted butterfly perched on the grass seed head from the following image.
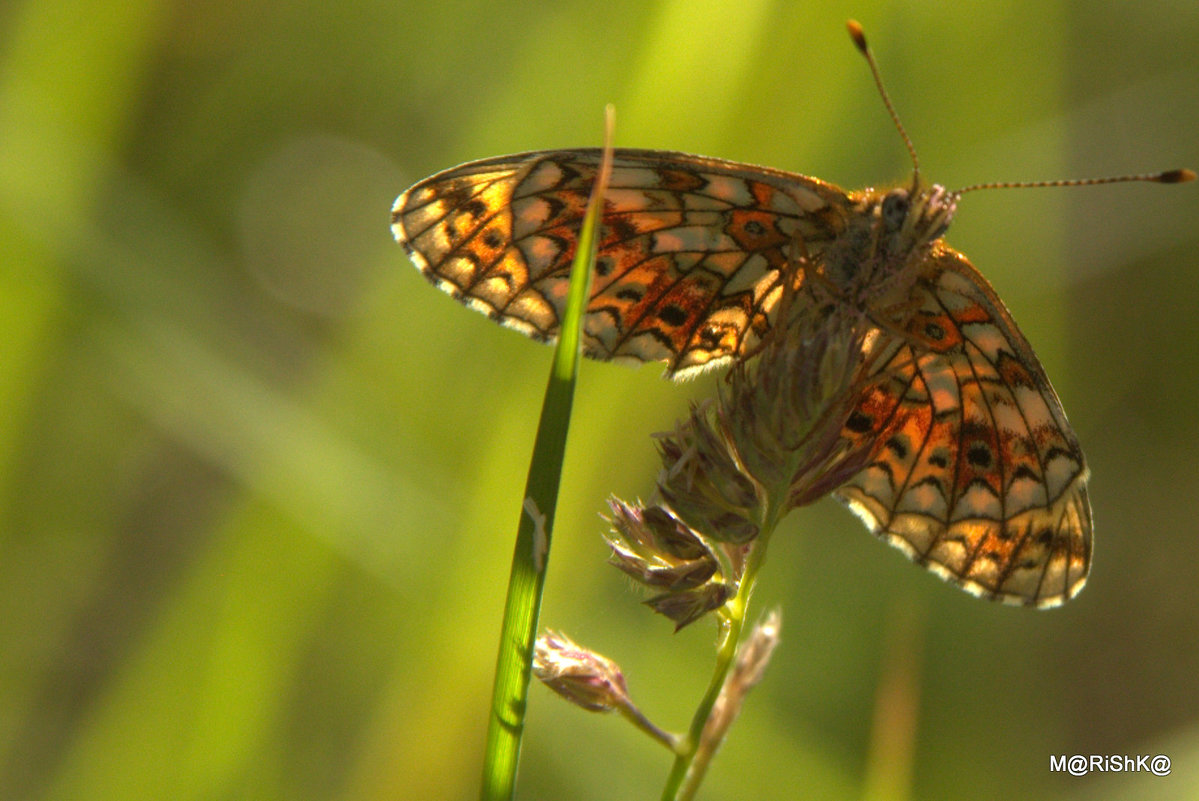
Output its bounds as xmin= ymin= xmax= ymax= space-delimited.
xmin=392 ymin=150 xmax=1091 ymax=606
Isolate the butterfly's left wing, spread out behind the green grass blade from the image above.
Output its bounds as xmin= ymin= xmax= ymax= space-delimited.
xmin=392 ymin=150 xmax=848 ymax=377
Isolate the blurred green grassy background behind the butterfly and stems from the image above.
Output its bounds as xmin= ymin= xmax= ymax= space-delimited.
xmin=0 ymin=0 xmax=1199 ymax=801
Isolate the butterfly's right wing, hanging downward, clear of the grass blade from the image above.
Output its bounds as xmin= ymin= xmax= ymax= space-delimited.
xmin=837 ymin=243 xmax=1091 ymax=607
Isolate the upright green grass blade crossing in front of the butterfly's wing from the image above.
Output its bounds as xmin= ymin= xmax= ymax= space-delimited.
xmin=478 ymin=106 xmax=614 ymax=801
